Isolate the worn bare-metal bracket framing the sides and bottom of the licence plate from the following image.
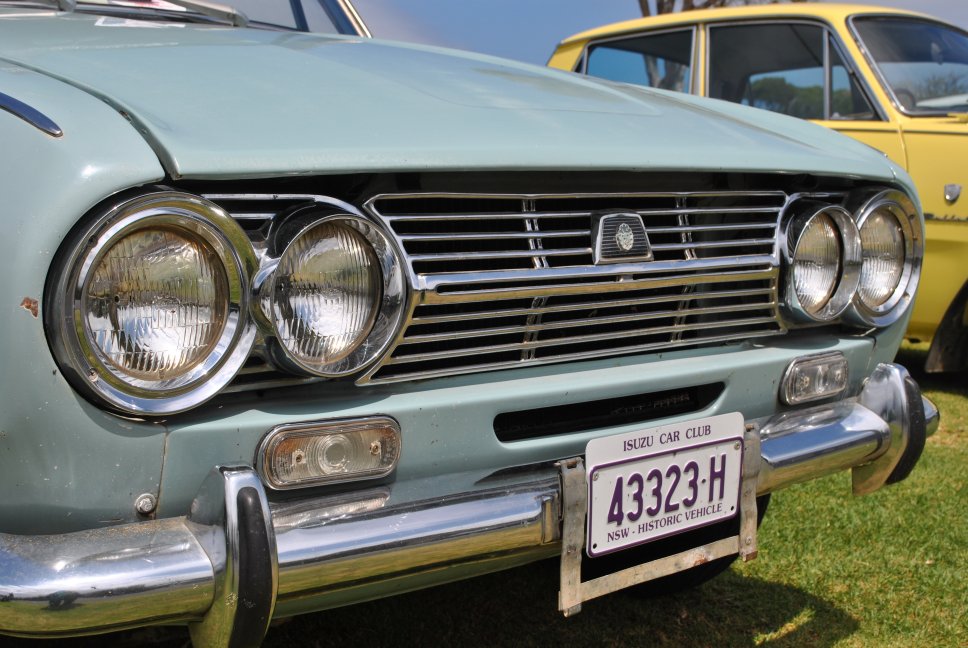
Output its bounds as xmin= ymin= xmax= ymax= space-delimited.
xmin=558 ymin=415 xmax=760 ymax=616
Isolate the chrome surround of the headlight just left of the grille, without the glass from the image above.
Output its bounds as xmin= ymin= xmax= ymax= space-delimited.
xmin=254 ymin=207 xmax=407 ymax=378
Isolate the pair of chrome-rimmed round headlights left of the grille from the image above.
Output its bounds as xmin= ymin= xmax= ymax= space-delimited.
xmin=47 ymin=192 xmax=404 ymax=415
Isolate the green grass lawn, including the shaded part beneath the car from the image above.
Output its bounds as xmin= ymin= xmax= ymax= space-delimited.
xmin=9 ymin=349 xmax=968 ymax=648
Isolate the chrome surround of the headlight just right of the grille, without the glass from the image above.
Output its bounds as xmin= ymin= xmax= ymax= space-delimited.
xmin=782 ymin=203 xmax=861 ymax=322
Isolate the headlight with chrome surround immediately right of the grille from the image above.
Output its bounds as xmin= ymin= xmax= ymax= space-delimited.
xmin=786 ymin=206 xmax=860 ymax=322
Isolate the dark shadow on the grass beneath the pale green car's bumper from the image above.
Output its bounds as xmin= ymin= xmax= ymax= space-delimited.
xmin=265 ymin=561 xmax=858 ymax=648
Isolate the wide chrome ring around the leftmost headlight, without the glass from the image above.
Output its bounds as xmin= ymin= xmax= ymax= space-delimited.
xmin=47 ymin=191 xmax=258 ymax=415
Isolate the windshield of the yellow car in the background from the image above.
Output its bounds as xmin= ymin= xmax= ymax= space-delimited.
xmin=854 ymin=17 xmax=968 ymax=116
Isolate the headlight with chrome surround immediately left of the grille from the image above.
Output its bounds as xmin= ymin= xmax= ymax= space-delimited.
xmin=260 ymin=214 xmax=404 ymax=376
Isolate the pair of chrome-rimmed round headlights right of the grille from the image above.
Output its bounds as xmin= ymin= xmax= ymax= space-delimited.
xmin=785 ymin=190 xmax=923 ymax=326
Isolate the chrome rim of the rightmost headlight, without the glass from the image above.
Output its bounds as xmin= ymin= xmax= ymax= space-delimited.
xmin=845 ymin=189 xmax=924 ymax=327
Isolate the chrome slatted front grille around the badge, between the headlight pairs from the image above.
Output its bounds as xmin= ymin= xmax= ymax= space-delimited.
xmin=367 ymin=192 xmax=787 ymax=382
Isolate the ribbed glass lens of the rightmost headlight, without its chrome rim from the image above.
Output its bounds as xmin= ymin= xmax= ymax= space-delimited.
xmin=857 ymin=208 xmax=905 ymax=309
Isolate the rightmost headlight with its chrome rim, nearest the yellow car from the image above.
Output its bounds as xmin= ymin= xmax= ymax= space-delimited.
xmin=850 ymin=190 xmax=924 ymax=326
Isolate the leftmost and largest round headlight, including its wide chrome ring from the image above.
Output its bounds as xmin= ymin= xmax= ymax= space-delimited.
xmin=48 ymin=192 xmax=256 ymax=414
